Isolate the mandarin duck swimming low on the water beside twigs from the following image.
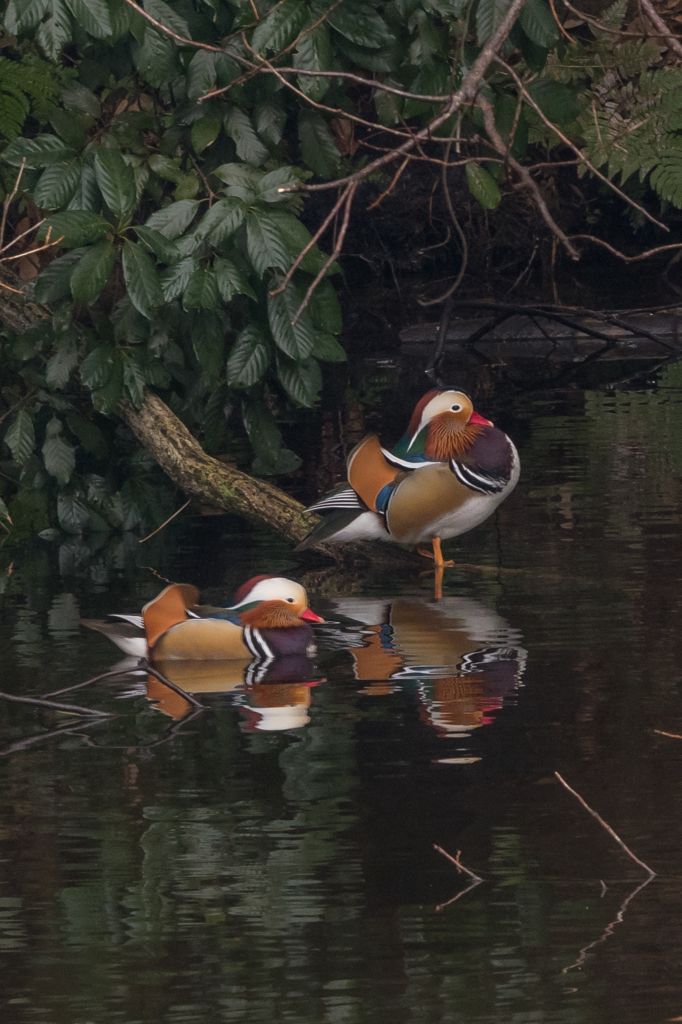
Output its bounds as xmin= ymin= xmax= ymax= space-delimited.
xmin=82 ymin=575 xmax=323 ymax=662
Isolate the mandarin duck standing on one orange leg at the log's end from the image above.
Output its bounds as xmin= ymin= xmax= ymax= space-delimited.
xmin=296 ymin=389 xmax=520 ymax=566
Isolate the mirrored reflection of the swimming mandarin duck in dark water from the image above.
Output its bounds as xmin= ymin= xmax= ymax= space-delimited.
xmin=145 ymin=654 xmax=324 ymax=732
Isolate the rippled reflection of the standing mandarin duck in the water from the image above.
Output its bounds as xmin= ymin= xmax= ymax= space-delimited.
xmin=321 ymin=597 xmax=526 ymax=737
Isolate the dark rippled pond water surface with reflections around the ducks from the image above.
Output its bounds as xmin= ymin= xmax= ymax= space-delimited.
xmin=0 ymin=367 xmax=682 ymax=1024
